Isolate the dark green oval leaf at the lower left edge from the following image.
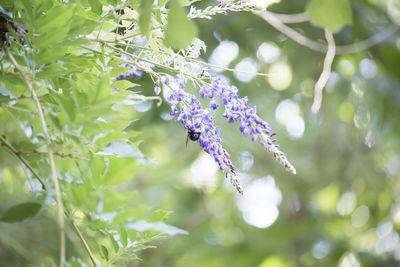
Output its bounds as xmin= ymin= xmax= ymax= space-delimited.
xmin=0 ymin=202 xmax=42 ymax=223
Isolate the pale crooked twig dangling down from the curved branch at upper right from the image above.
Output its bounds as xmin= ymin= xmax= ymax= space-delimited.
xmin=311 ymin=29 xmax=336 ymax=113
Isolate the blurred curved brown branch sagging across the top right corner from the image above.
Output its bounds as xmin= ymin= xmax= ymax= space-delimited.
xmin=254 ymin=11 xmax=400 ymax=55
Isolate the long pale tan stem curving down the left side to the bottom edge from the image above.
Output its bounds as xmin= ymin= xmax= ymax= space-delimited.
xmin=7 ymin=51 xmax=65 ymax=267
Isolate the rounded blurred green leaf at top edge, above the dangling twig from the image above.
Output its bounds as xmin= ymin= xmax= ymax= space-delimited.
xmin=307 ymin=0 xmax=353 ymax=32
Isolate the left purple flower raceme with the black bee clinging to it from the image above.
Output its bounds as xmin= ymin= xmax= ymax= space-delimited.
xmin=167 ymin=80 xmax=243 ymax=194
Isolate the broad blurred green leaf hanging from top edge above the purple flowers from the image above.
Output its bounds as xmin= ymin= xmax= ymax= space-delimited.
xmin=164 ymin=0 xmax=197 ymax=49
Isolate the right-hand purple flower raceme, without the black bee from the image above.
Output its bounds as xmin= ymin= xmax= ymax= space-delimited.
xmin=199 ymin=78 xmax=296 ymax=176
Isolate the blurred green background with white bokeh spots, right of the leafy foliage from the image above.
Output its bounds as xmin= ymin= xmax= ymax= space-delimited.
xmin=130 ymin=0 xmax=400 ymax=267
